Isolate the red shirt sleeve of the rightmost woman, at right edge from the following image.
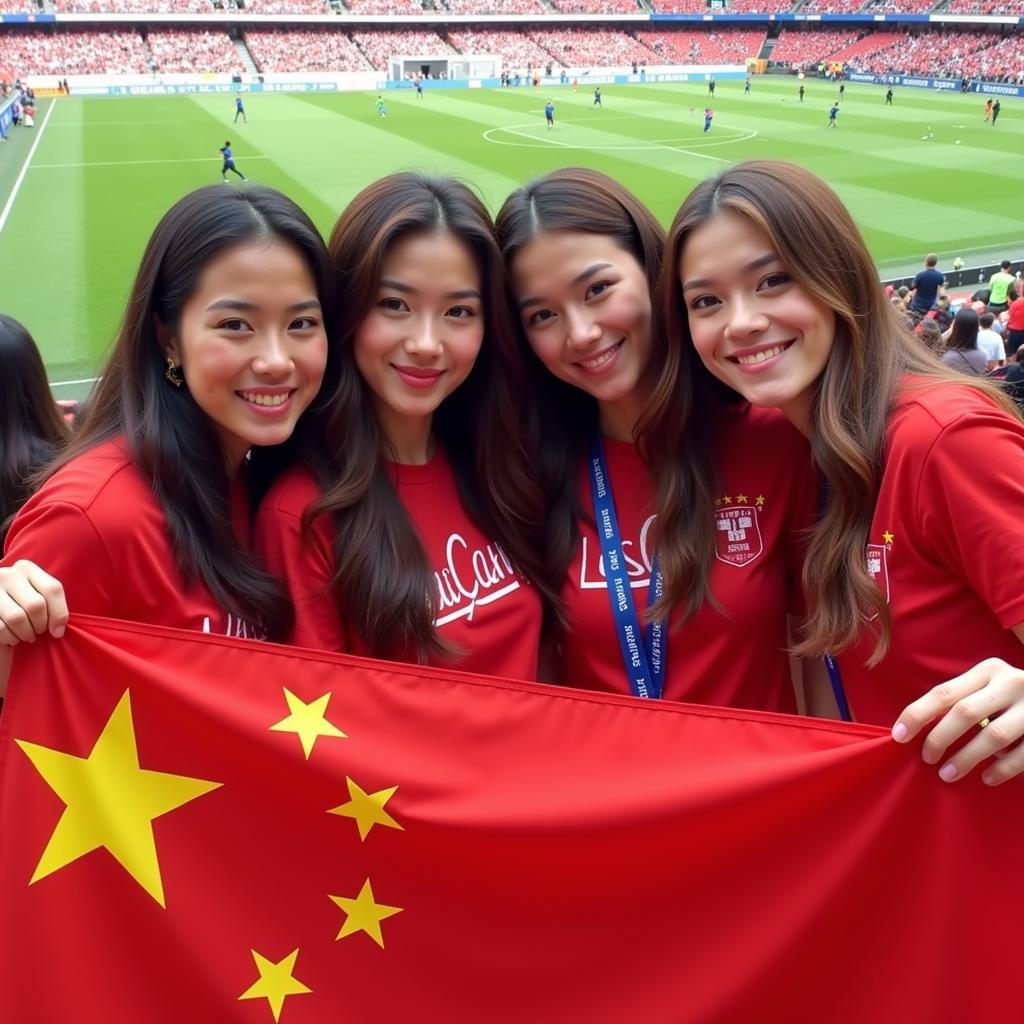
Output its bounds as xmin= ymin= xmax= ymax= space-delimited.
xmin=918 ymin=409 xmax=1024 ymax=629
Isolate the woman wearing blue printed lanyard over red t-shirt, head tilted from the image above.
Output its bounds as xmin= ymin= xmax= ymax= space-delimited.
xmin=497 ymin=169 xmax=816 ymax=712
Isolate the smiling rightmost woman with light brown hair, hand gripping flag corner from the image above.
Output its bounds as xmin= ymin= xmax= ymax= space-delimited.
xmin=664 ymin=162 xmax=1024 ymax=785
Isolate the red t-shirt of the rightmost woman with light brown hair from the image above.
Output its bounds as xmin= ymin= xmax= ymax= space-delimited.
xmin=840 ymin=384 xmax=1024 ymax=725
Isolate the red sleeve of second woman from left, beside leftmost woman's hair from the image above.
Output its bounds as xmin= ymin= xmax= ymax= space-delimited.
xmin=253 ymin=502 xmax=351 ymax=653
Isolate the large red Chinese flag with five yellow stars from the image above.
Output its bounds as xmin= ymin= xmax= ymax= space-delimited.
xmin=0 ymin=616 xmax=1024 ymax=1024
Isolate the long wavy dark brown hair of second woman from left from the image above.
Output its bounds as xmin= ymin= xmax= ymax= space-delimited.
xmin=303 ymin=172 xmax=557 ymax=662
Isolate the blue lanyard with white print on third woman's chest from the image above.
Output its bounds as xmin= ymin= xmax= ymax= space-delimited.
xmin=588 ymin=434 xmax=666 ymax=700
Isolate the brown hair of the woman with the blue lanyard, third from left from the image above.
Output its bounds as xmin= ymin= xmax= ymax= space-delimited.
xmin=495 ymin=167 xmax=665 ymax=584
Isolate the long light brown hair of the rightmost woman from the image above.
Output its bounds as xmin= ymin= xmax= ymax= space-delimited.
xmin=652 ymin=161 xmax=1015 ymax=665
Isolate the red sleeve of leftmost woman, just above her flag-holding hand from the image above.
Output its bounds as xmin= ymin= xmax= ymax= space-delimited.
xmin=0 ymin=502 xmax=117 ymax=617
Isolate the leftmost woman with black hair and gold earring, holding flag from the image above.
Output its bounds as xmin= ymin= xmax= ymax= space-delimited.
xmin=0 ymin=186 xmax=333 ymax=696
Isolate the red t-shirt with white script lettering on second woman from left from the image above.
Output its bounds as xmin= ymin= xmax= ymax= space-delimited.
xmin=255 ymin=451 xmax=542 ymax=680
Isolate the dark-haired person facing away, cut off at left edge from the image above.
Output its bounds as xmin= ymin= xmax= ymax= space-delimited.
xmin=0 ymin=313 xmax=68 ymax=544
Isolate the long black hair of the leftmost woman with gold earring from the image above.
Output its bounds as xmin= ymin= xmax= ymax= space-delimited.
xmin=39 ymin=185 xmax=335 ymax=637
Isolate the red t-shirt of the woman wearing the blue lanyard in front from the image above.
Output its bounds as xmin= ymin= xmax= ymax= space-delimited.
xmin=558 ymin=407 xmax=818 ymax=714
